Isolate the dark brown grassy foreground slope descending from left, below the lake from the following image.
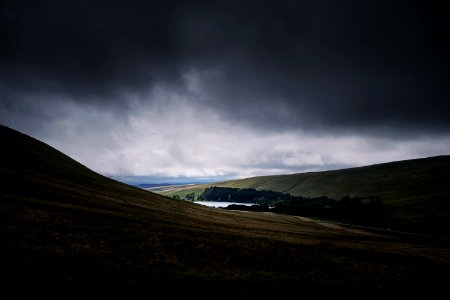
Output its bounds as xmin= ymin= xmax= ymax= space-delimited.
xmin=0 ymin=127 xmax=450 ymax=299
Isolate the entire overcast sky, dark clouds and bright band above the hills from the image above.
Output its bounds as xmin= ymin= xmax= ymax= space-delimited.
xmin=0 ymin=0 xmax=450 ymax=182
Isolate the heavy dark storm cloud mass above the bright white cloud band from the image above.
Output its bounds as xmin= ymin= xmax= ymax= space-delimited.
xmin=0 ymin=1 xmax=450 ymax=132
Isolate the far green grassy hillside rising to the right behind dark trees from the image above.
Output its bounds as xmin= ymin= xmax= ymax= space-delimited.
xmin=159 ymin=155 xmax=450 ymax=203
